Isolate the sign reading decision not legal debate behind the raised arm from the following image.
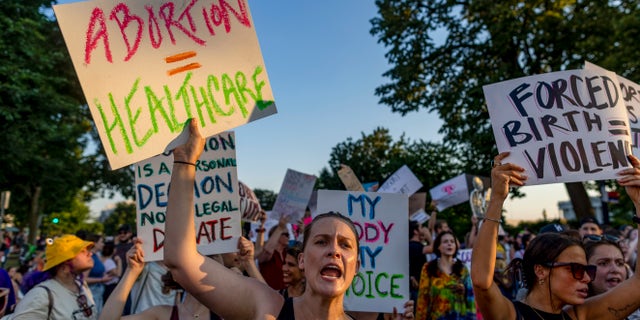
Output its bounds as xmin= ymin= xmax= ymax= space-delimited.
xmin=135 ymin=132 xmax=242 ymax=261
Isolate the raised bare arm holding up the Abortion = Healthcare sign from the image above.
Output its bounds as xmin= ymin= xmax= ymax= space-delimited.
xmin=165 ymin=119 xmax=282 ymax=319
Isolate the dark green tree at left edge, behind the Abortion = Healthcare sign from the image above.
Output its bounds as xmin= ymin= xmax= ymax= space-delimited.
xmin=0 ymin=0 xmax=132 ymax=243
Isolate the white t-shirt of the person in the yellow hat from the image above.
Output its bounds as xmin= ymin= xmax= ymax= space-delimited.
xmin=2 ymin=279 xmax=98 ymax=320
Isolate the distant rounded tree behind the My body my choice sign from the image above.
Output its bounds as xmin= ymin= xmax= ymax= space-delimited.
xmin=316 ymin=127 xmax=478 ymax=239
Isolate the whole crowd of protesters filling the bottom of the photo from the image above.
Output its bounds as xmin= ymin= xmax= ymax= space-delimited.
xmin=0 ymin=124 xmax=640 ymax=320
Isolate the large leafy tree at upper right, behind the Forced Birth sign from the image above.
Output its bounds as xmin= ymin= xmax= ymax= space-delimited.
xmin=371 ymin=0 xmax=640 ymax=221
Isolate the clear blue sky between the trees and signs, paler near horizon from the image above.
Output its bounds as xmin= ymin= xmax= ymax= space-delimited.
xmin=66 ymin=0 xmax=568 ymax=224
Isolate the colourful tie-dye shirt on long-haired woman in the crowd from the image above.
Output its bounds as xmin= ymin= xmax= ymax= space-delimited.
xmin=416 ymin=260 xmax=476 ymax=320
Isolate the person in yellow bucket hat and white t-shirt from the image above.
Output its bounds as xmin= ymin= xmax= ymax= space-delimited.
xmin=2 ymin=235 xmax=98 ymax=320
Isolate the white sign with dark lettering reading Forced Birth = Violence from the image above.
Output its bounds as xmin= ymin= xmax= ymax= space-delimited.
xmin=483 ymin=69 xmax=631 ymax=185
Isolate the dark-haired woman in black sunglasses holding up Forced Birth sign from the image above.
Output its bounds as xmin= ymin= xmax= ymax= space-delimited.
xmin=471 ymin=152 xmax=640 ymax=320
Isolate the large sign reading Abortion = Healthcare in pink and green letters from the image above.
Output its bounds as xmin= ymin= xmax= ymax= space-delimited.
xmin=53 ymin=0 xmax=276 ymax=169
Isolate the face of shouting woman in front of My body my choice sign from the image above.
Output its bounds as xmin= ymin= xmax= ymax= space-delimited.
xmin=298 ymin=217 xmax=360 ymax=297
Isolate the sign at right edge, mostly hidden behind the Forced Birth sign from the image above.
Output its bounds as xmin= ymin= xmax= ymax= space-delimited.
xmin=584 ymin=61 xmax=640 ymax=157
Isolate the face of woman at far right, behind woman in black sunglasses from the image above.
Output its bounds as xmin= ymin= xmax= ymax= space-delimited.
xmin=589 ymin=244 xmax=627 ymax=294
